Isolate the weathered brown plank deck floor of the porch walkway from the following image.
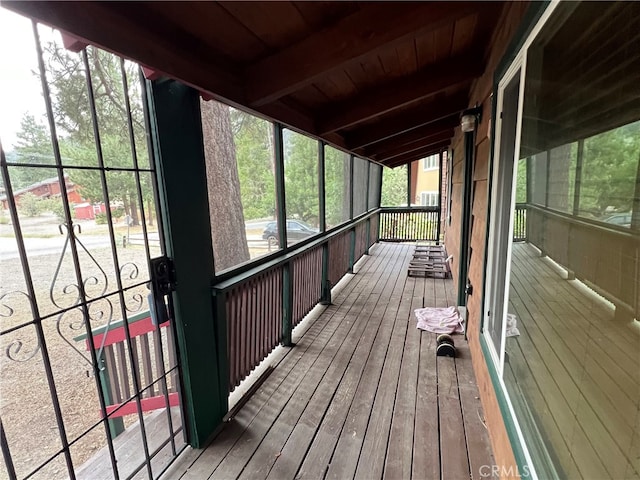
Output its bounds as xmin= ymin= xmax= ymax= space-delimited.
xmin=165 ymin=244 xmax=494 ymax=480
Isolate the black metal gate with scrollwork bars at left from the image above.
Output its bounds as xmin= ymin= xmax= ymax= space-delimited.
xmin=0 ymin=13 xmax=186 ymax=478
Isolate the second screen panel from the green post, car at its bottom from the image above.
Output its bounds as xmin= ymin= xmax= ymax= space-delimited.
xmin=282 ymin=129 xmax=320 ymax=245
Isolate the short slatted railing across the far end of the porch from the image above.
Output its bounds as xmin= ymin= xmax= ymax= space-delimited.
xmin=380 ymin=207 xmax=440 ymax=242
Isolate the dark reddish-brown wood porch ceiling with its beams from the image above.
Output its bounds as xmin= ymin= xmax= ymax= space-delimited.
xmin=3 ymin=1 xmax=503 ymax=167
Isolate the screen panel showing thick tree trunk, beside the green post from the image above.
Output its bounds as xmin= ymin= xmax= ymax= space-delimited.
xmin=201 ymin=100 xmax=278 ymax=272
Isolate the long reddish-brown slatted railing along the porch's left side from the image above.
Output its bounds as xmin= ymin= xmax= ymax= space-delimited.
xmin=213 ymin=210 xmax=379 ymax=392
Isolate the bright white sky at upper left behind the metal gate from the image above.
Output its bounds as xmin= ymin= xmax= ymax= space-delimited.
xmin=0 ymin=7 xmax=50 ymax=151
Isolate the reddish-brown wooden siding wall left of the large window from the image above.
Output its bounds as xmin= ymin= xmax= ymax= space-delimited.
xmin=445 ymin=2 xmax=528 ymax=474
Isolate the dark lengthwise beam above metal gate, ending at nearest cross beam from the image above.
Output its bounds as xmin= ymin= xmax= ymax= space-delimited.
xmin=2 ymin=1 xmax=245 ymax=104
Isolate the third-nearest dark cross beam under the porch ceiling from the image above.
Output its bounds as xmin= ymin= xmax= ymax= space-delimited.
xmin=345 ymin=91 xmax=469 ymax=150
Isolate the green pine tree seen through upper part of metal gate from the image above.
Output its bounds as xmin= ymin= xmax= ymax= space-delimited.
xmin=33 ymin=42 xmax=152 ymax=225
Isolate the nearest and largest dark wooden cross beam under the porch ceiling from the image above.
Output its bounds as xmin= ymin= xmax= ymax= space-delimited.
xmin=245 ymin=2 xmax=482 ymax=107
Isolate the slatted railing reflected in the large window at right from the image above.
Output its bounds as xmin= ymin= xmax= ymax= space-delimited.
xmin=527 ymin=205 xmax=640 ymax=319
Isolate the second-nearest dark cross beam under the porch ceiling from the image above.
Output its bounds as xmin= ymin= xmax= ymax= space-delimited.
xmin=318 ymin=55 xmax=484 ymax=134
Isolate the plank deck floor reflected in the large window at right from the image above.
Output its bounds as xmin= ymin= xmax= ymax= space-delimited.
xmin=505 ymin=244 xmax=640 ymax=479
